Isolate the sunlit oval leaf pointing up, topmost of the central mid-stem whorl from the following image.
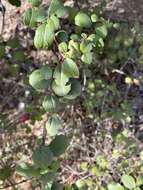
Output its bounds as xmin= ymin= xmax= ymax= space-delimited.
xmin=62 ymin=58 xmax=79 ymax=78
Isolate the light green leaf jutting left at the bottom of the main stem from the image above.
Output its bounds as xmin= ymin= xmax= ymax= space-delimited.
xmin=16 ymin=163 xmax=40 ymax=177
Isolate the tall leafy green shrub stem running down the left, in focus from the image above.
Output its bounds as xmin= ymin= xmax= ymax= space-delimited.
xmin=14 ymin=0 xmax=108 ymax=190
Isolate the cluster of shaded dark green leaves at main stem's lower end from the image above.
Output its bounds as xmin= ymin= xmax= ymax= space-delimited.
xmin=16 ymin=135 xmax=69 ymax=181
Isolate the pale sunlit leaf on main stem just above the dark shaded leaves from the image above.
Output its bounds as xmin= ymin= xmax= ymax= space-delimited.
xmin=46 ymin=115 xmax=62 ymax=136
